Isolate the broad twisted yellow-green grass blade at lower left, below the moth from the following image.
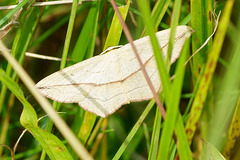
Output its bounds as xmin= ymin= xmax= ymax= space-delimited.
xmin=0 ymin=69 xmax=72 ymax=160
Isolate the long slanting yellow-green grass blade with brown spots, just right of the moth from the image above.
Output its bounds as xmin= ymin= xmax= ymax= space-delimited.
xmin=186 ymin=0 xmax=234 ymax=144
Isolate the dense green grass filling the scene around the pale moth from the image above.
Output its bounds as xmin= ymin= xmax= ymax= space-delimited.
xmin=0 ymin=0 xmax=240 ymax=160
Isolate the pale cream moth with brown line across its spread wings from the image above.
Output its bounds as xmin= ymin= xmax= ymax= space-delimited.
xmin=36 ymin=26 xmax=193 ymax=117
